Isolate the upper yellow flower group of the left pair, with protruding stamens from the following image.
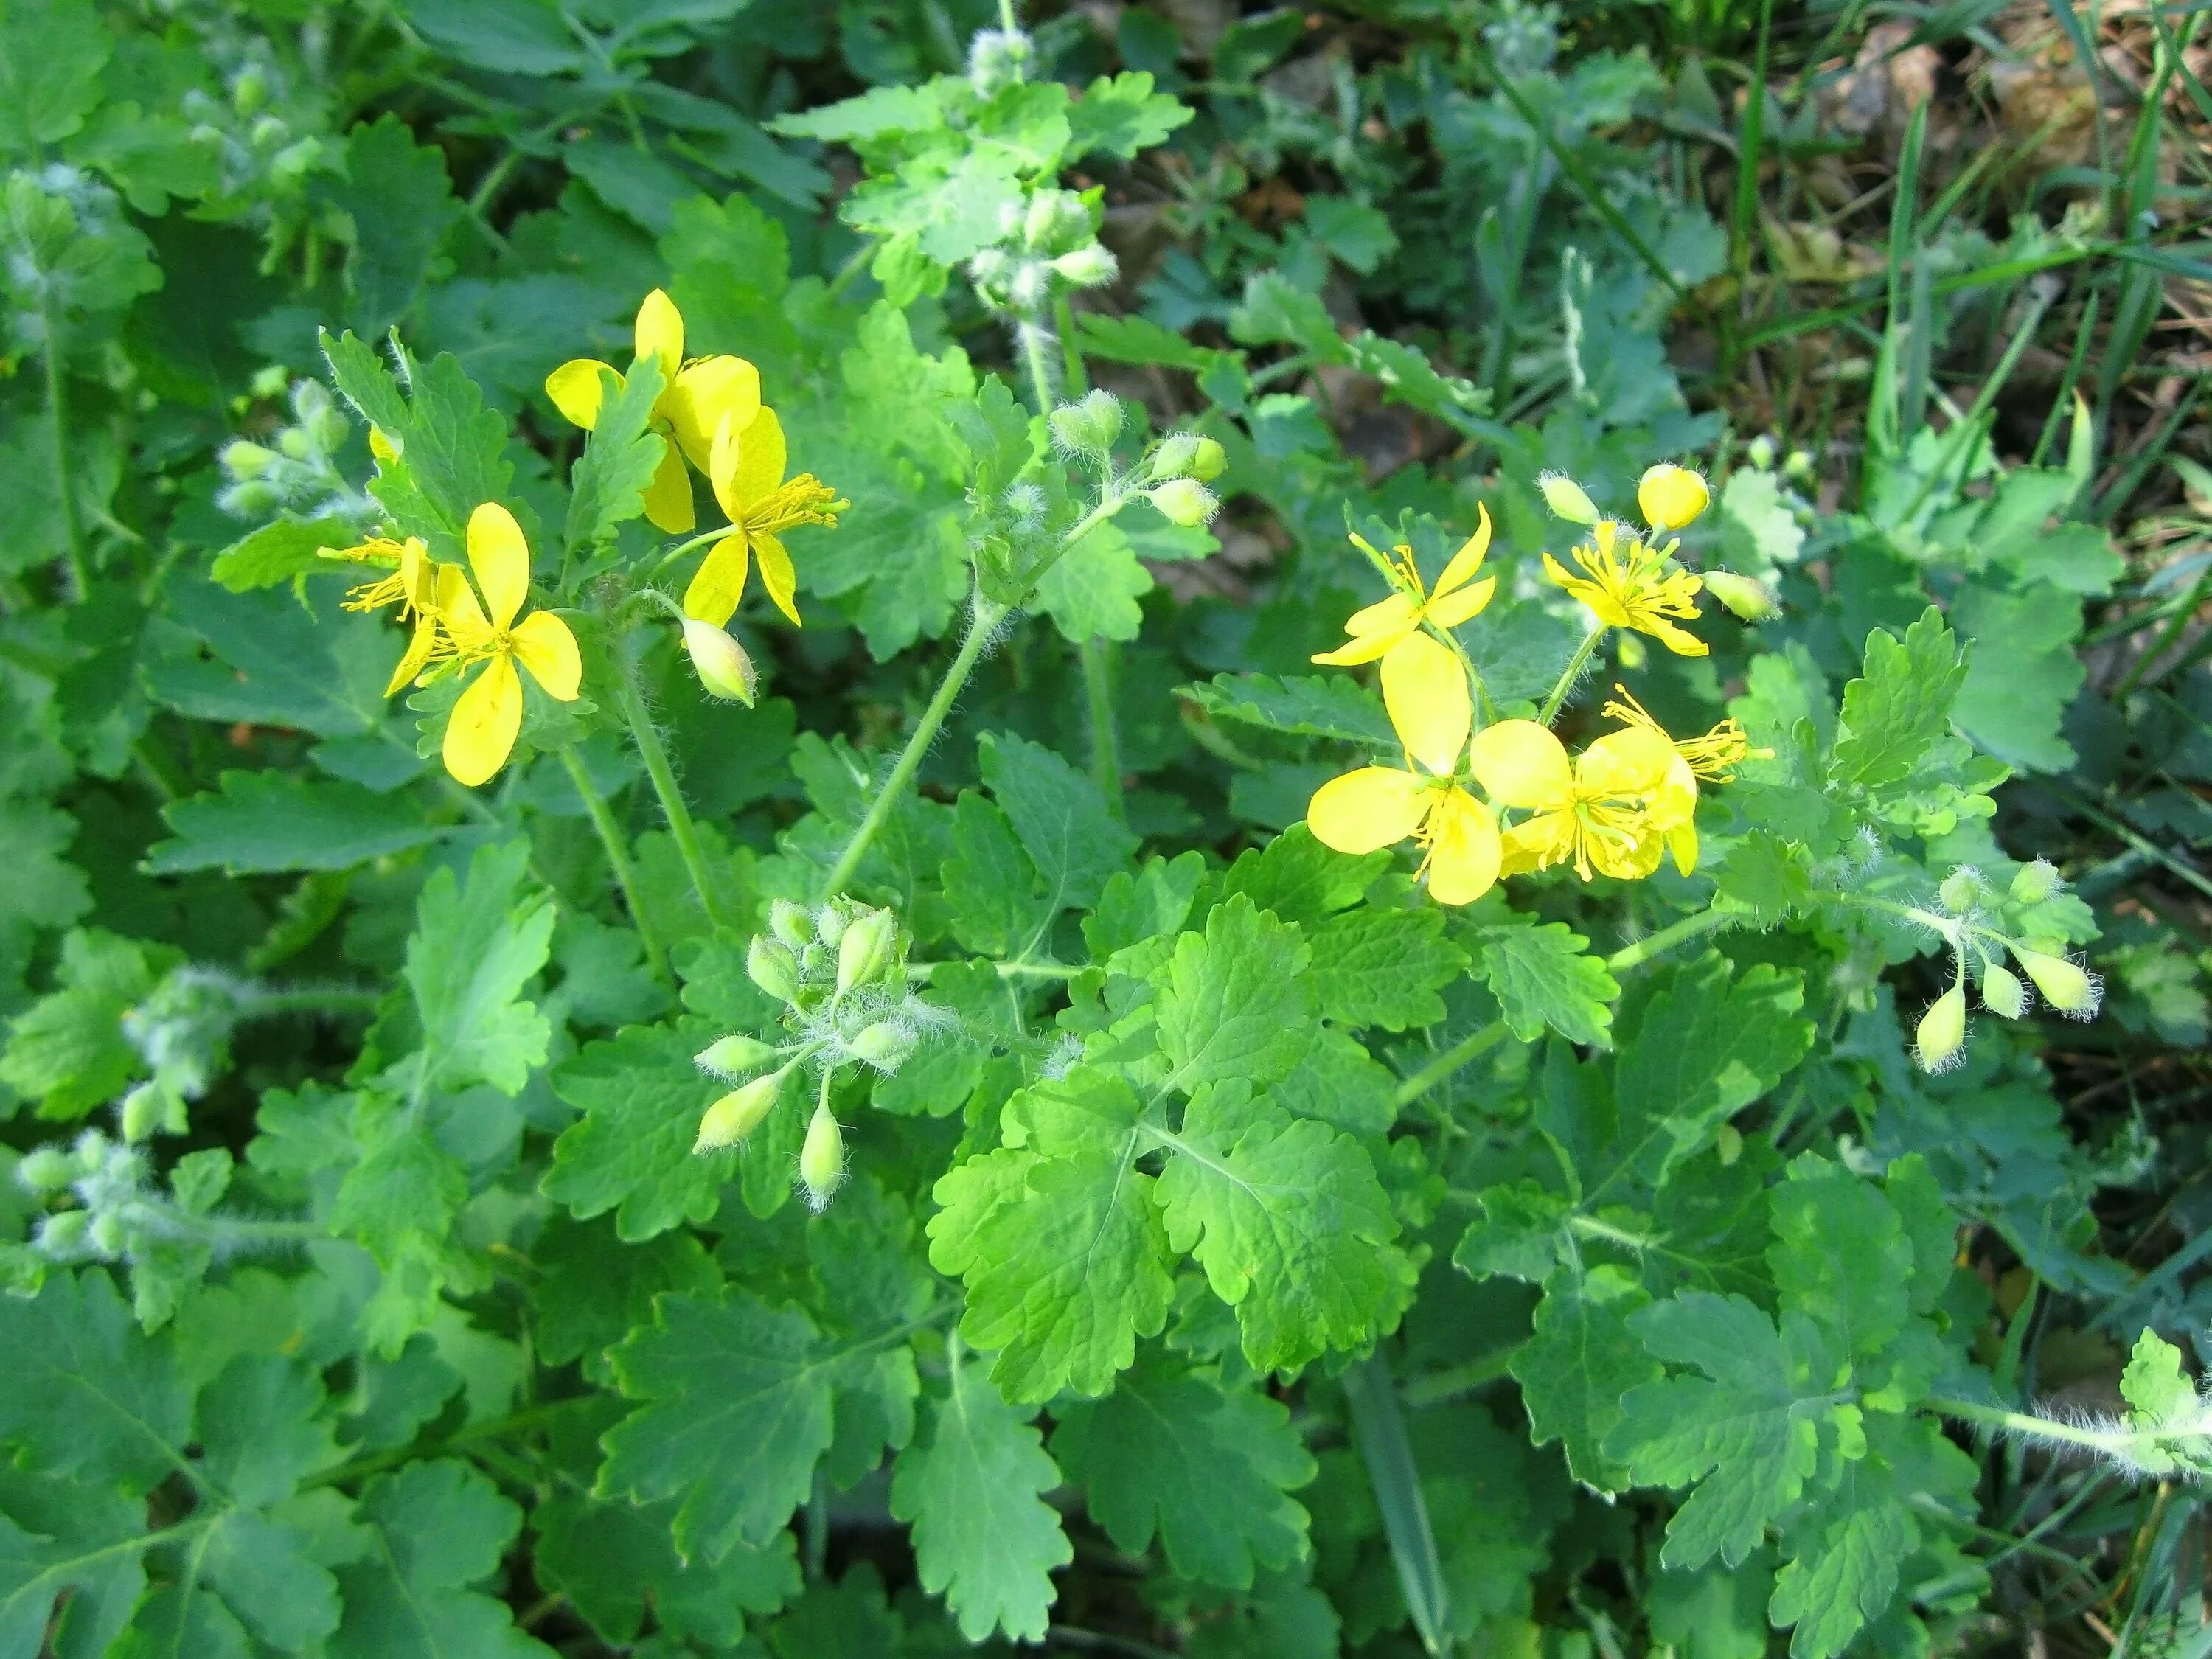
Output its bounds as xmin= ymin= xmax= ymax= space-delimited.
xmin=546 ymin=288 xmax=845 ymax=628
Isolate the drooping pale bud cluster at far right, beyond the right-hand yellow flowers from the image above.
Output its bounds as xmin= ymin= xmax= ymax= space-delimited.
xmin=1913 ymin=858 xmax=2104 ymax=1071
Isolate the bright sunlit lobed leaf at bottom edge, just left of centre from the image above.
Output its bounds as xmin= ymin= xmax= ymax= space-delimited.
xmin=891 ymin=1365 xmax=1075 ymax=1641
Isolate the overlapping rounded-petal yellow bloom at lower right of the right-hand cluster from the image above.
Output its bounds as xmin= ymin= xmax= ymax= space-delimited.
xmin=1469 ymin=721 xmax=1697 ymax=880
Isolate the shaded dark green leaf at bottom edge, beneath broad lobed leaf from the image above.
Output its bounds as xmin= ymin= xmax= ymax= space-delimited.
xmin=531 ymin=1493 xmax=801 ymax=1648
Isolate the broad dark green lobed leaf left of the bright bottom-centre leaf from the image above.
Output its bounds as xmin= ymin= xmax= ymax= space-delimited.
xmin=599 ymin=1292 xmax=841 ymax=1562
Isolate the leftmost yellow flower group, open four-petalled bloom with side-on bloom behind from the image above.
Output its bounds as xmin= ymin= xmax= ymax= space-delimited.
xmin=325 ymin=502 xmax=584 ymax=787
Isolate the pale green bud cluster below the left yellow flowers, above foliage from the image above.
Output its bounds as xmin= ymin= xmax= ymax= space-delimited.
xmin=692 ymin=898 xmax=949 ymax=1210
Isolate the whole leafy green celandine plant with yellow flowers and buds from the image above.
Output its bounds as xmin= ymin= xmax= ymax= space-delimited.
xmin=0 ymin=4 xmax=2212 ymax=1659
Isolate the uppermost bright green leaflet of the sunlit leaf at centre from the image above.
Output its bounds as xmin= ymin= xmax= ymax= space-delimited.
xmin=1159 ymin=894 xmax=1314 ymax=1091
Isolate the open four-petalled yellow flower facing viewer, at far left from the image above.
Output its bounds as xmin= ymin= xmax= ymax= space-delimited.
xmin=438 ymin=502 xmax=584 ymax=785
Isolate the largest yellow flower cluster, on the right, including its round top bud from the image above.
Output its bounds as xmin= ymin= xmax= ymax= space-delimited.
xmin=1305 ymin=469 xmax=1752 ymax=905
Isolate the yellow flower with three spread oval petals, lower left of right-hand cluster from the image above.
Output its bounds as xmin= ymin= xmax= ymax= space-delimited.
xmin=1305 ymin=633 xmax=1498 ymax=905
